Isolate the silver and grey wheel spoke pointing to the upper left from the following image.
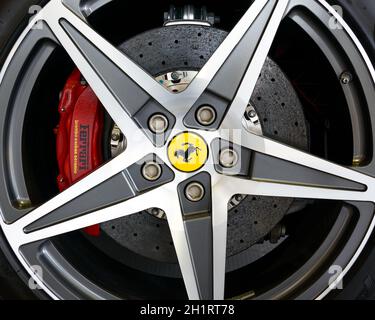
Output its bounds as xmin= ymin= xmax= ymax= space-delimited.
xmin=42 ymin=0 xmax=170 ymax=138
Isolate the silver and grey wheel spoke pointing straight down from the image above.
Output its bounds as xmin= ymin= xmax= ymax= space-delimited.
xmin=163 ymin=172 xmax=229 ymax=300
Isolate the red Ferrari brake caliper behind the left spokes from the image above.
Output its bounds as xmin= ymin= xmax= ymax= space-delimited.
xmin=56 ymin=70 xmax=104 ymax=236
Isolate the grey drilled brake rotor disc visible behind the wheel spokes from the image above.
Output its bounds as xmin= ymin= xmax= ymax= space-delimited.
xmin=97 ymin=25 xmax=308 ymax=273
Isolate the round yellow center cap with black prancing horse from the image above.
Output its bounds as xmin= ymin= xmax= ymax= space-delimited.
xmin=168 ymin=132 xmax=208 ymax=172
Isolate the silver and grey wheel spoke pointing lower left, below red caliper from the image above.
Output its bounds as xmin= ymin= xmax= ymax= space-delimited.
xmin=9 ymin=149 xmax=174 ymax=242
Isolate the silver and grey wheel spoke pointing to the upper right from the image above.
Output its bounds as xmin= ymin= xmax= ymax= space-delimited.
xmin=185 ymin=0 xmax=289 ymax=129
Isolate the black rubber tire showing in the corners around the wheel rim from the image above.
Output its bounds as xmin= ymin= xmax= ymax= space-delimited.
xmin=0 ymin=0 xmax=375 ymax=299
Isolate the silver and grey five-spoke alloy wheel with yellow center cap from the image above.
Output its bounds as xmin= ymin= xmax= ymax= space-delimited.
xmin=0 ymin=0 xmax=375 ymax=299
